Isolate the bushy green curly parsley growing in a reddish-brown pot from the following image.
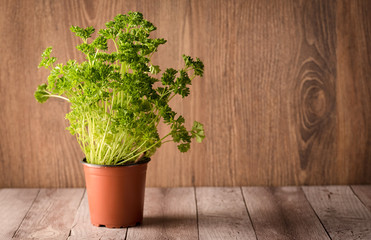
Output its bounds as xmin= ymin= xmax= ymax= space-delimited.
xmin=35 ymin=12 xmax=204 ymax=227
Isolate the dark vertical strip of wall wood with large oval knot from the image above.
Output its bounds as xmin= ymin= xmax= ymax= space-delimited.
xmin=289 ymin=1 xmax=337 ymax=184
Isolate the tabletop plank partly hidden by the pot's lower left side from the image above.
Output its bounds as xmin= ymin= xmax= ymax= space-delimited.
xmin=68 ymin=193 xmax=127 ymax=240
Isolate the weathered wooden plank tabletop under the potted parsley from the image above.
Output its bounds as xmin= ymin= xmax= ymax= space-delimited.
xmin=0 ymin=185 xmax=371 ymax=240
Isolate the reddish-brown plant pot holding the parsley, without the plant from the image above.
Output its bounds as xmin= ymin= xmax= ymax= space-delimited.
xmin=82 ymin=159 xmax=148 ymax=228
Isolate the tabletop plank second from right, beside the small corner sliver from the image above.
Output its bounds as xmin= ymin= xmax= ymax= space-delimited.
xmin=303 ymin=186 xmax=371 ymax=240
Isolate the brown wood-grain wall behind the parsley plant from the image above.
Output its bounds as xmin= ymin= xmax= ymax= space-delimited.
xmin=0 ymin=0 xmax=371 ymax=187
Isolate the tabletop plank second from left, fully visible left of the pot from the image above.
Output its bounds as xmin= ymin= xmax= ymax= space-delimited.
xmin=14 ymin=189 xmax=84 ymax=240
